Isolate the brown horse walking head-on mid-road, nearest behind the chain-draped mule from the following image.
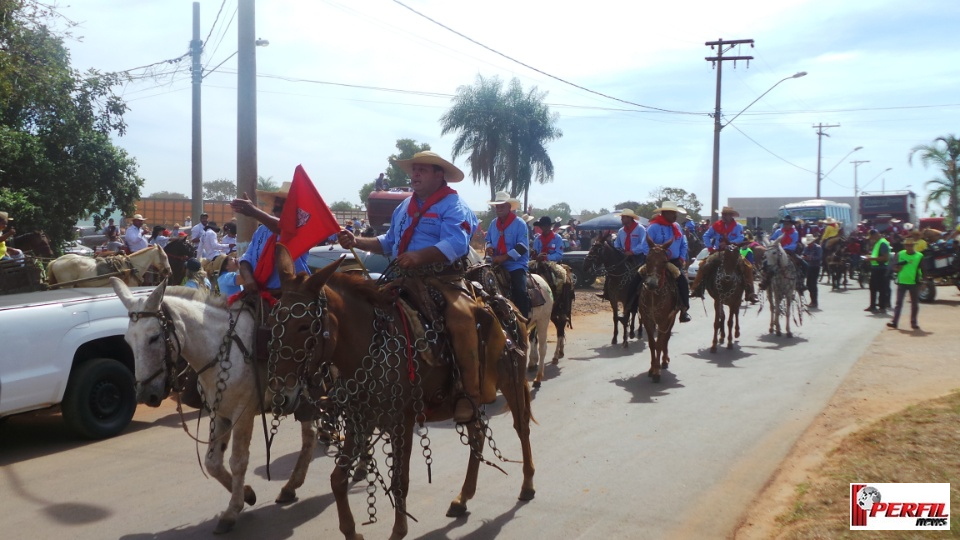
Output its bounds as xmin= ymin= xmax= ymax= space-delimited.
xmin=639 ymin=236 xmax=684 ymax=383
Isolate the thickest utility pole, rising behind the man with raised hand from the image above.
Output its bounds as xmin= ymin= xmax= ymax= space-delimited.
xmin=237 ymin=0 xmax=257 ymax=245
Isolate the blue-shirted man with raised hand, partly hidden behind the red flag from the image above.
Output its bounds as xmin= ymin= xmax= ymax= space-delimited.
xmin=230 ymin=182 xmax=310 ymax=291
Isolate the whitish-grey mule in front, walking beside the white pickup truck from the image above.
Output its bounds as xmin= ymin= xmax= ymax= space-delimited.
xmin=110 ymin=278 xmax=317 ymax=533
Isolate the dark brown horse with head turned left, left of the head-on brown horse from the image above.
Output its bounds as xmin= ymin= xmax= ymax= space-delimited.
xmin=583 ymin=240 xmax=640 ymax=349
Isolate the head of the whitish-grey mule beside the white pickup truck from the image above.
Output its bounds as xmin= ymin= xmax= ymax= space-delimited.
xmin=110 ymin=277 xmax=176 ymax=407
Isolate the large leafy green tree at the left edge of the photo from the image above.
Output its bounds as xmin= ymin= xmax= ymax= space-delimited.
xmin=0 ymin=0 xmax=143 ymax=246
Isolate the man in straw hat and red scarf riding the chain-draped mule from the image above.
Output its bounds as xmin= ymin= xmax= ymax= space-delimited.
xmin=338 ymin=152 xmax=488 ymax=423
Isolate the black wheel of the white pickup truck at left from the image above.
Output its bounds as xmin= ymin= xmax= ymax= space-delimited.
xmin=61 ymin=358 xmax=137 ymax=439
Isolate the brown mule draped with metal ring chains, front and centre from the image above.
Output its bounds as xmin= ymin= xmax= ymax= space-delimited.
xmin=268 ymin=245 xmax=534 ymax=540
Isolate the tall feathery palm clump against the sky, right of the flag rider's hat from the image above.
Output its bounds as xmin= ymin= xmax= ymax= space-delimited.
xmin=440 ymin=75 xmax=562 ymax=207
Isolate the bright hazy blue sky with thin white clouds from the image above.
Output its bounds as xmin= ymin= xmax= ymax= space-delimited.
xmin=62 ymin=0 xmax=960 ymax=213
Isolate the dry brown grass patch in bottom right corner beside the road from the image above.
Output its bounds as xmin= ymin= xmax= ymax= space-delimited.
xmin=777 ymin=393 xmax=960 ymax=539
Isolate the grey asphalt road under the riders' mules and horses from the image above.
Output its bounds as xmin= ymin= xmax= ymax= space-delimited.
xmin=0 ymin=288 xmax=885 ymax=540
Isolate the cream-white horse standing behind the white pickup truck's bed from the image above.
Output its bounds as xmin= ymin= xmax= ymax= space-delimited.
xmin=47 ymin=246 xmax=170 ymax=287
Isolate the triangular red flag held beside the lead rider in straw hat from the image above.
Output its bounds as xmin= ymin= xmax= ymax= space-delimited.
xmin=253 ymin=165 xmax=340 ymax=288
